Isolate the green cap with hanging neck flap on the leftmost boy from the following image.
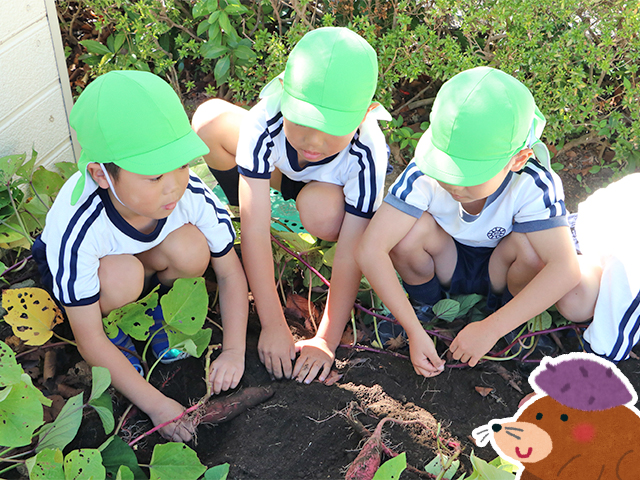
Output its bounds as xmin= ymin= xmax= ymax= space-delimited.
xmin=69 ymin=70 xmax=209 ymax=205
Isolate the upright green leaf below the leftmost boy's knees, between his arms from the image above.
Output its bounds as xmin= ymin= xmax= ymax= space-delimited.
xmin=160 ymin=277 xmax=209 ymax=335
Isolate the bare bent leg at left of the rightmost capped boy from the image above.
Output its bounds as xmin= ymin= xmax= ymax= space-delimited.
xmin=389 ymin=212 xmax=457 ymax=286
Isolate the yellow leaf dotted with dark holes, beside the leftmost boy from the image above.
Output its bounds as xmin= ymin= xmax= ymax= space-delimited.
xmin=2 ymin=288 xmax=63 ymax=345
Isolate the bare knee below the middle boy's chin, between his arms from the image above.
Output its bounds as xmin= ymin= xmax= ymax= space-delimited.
xmin=296 ymin=182 xmax=345 ymax=242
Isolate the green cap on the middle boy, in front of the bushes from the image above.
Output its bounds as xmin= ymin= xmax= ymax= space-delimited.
xmin=282 ymin=27 xmax=378 ymax=136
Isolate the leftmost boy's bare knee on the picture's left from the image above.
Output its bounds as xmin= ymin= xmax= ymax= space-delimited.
xmin=98 ymin=255 xmax=144 ymax=315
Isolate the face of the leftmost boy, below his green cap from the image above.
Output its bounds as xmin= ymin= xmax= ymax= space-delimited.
xmin=109 ymin=165 xmax=189 ymax=220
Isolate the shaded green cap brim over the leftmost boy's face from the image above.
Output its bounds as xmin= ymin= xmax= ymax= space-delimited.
xmin=114 ymin=130 xmax=209 ymax=175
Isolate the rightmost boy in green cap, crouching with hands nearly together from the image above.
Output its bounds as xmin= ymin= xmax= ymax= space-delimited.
xmin=357 ymin=67 xmax=585 ymax=376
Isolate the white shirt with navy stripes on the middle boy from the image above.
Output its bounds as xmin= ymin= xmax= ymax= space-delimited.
xmin=236 ymin=93 xmax=391 ymax=218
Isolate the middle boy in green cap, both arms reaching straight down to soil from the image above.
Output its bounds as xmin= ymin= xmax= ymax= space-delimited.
xmin=192 ymin=27 xmax=391 ymax=383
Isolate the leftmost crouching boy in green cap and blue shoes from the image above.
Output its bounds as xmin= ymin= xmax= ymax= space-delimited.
xmin=33 ymin=71 xmax=248 ymax=441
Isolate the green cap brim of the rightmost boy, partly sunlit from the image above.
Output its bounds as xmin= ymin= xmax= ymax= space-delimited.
xmin=414 ymin=128 xmax=517 ymax=187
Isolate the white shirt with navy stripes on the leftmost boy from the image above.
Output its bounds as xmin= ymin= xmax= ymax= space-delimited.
xmin=40 ymin=172 xmax=235 ymax=306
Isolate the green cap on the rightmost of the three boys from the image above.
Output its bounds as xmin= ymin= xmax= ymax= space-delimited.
xmin=414 ymin=67 xmax=545 ymax=187
